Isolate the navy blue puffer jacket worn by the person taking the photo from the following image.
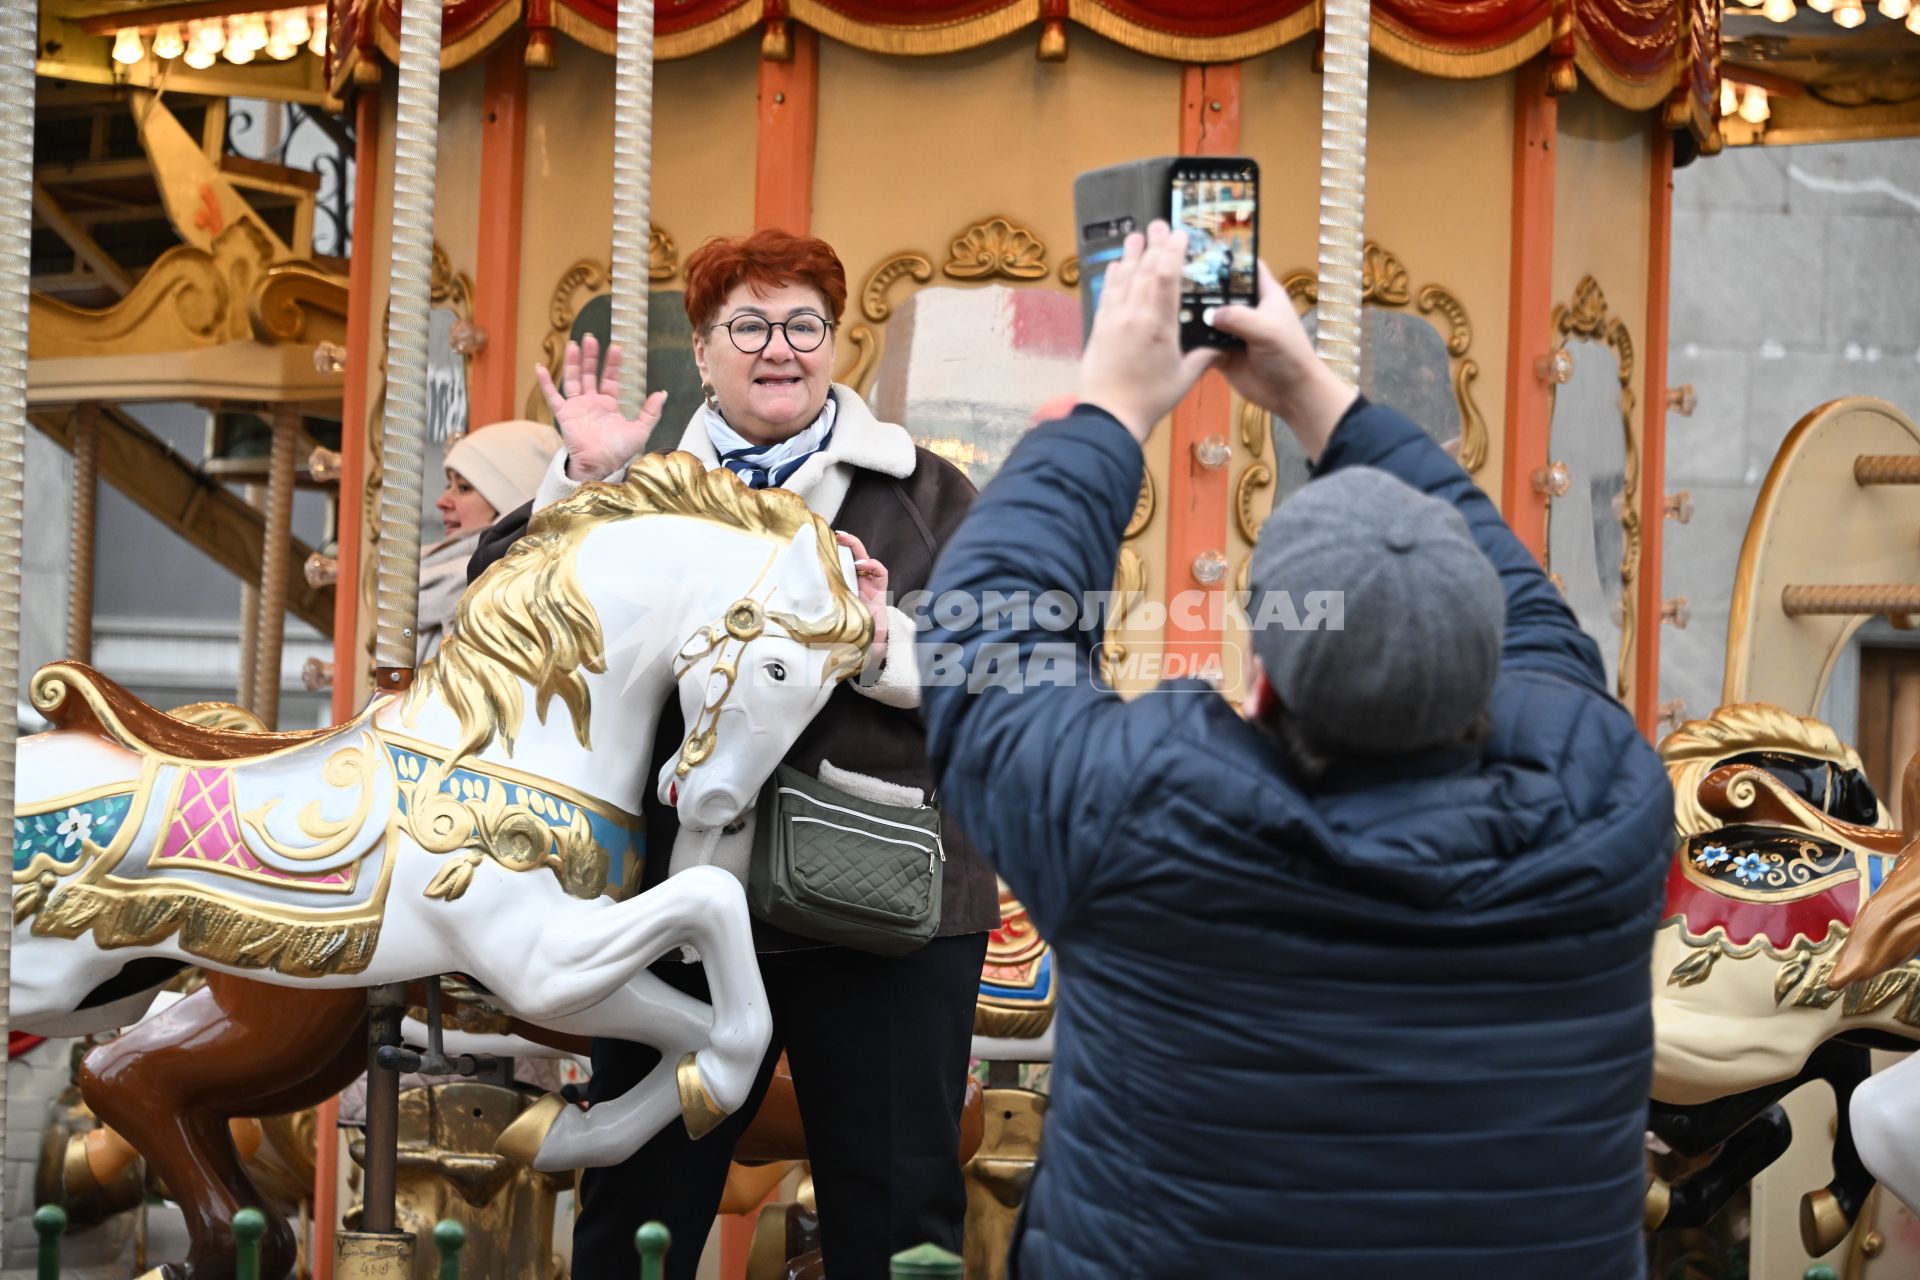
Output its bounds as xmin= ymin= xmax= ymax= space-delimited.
xmin=922 ymin=403 xmax=1672 ymax=1280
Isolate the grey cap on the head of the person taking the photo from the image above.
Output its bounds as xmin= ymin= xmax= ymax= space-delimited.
xmin=1248 ymin=466 xmax=1507 ymax=754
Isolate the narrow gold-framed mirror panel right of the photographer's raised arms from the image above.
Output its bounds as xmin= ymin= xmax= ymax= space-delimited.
xmin=1546 ymin=276 xmax=1640 ymax=697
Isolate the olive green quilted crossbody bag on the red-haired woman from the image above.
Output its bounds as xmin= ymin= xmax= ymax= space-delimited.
xmin=747 ymin=764 xmax=947 ymax=956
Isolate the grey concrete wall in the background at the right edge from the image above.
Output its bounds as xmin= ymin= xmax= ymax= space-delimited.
xmin=1661 ymin=140 xmax=1920 ymax=716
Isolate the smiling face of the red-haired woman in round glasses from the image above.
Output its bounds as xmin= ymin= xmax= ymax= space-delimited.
xmin=693 ymin=284 xmax=833 ymax=445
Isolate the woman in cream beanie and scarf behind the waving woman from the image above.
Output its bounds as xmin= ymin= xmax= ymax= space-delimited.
xmin=417 ymin=418 xmax=561 ymax=662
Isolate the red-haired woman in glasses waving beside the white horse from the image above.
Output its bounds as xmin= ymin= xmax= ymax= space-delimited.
xmin=472 ymin=230 xmax=998 ymax=1280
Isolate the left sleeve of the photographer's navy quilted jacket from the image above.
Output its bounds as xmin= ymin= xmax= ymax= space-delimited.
xmin=920 ymin=407 xmax=1165 ymax=938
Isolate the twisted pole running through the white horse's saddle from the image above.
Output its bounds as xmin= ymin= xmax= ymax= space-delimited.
xmin=341 ymin=0 xmax=442 ymax=1258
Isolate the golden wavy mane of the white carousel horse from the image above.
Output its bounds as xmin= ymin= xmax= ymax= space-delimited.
xmin=401 ymin=453 xmax=872 ymax=770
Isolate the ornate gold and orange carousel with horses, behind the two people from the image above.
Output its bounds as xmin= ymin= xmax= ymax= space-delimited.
xmin=0 ymin=0 xmax=1920 ymax=1280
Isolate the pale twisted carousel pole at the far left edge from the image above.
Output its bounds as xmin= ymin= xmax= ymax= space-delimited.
xmin=0 ymin=0 xmax=40 ymax=1201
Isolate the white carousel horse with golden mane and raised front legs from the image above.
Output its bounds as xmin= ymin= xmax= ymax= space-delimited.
xmin=12 ymin=455 xmax=872 ymax=1169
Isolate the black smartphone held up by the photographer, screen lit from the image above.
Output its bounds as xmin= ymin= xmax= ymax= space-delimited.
xmin=1167 ymin=155 xmax=1260 ymax=351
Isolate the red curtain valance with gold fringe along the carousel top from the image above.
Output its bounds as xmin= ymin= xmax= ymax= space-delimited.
xmin=328 ymin=0 xmax=1718 ymax=129
